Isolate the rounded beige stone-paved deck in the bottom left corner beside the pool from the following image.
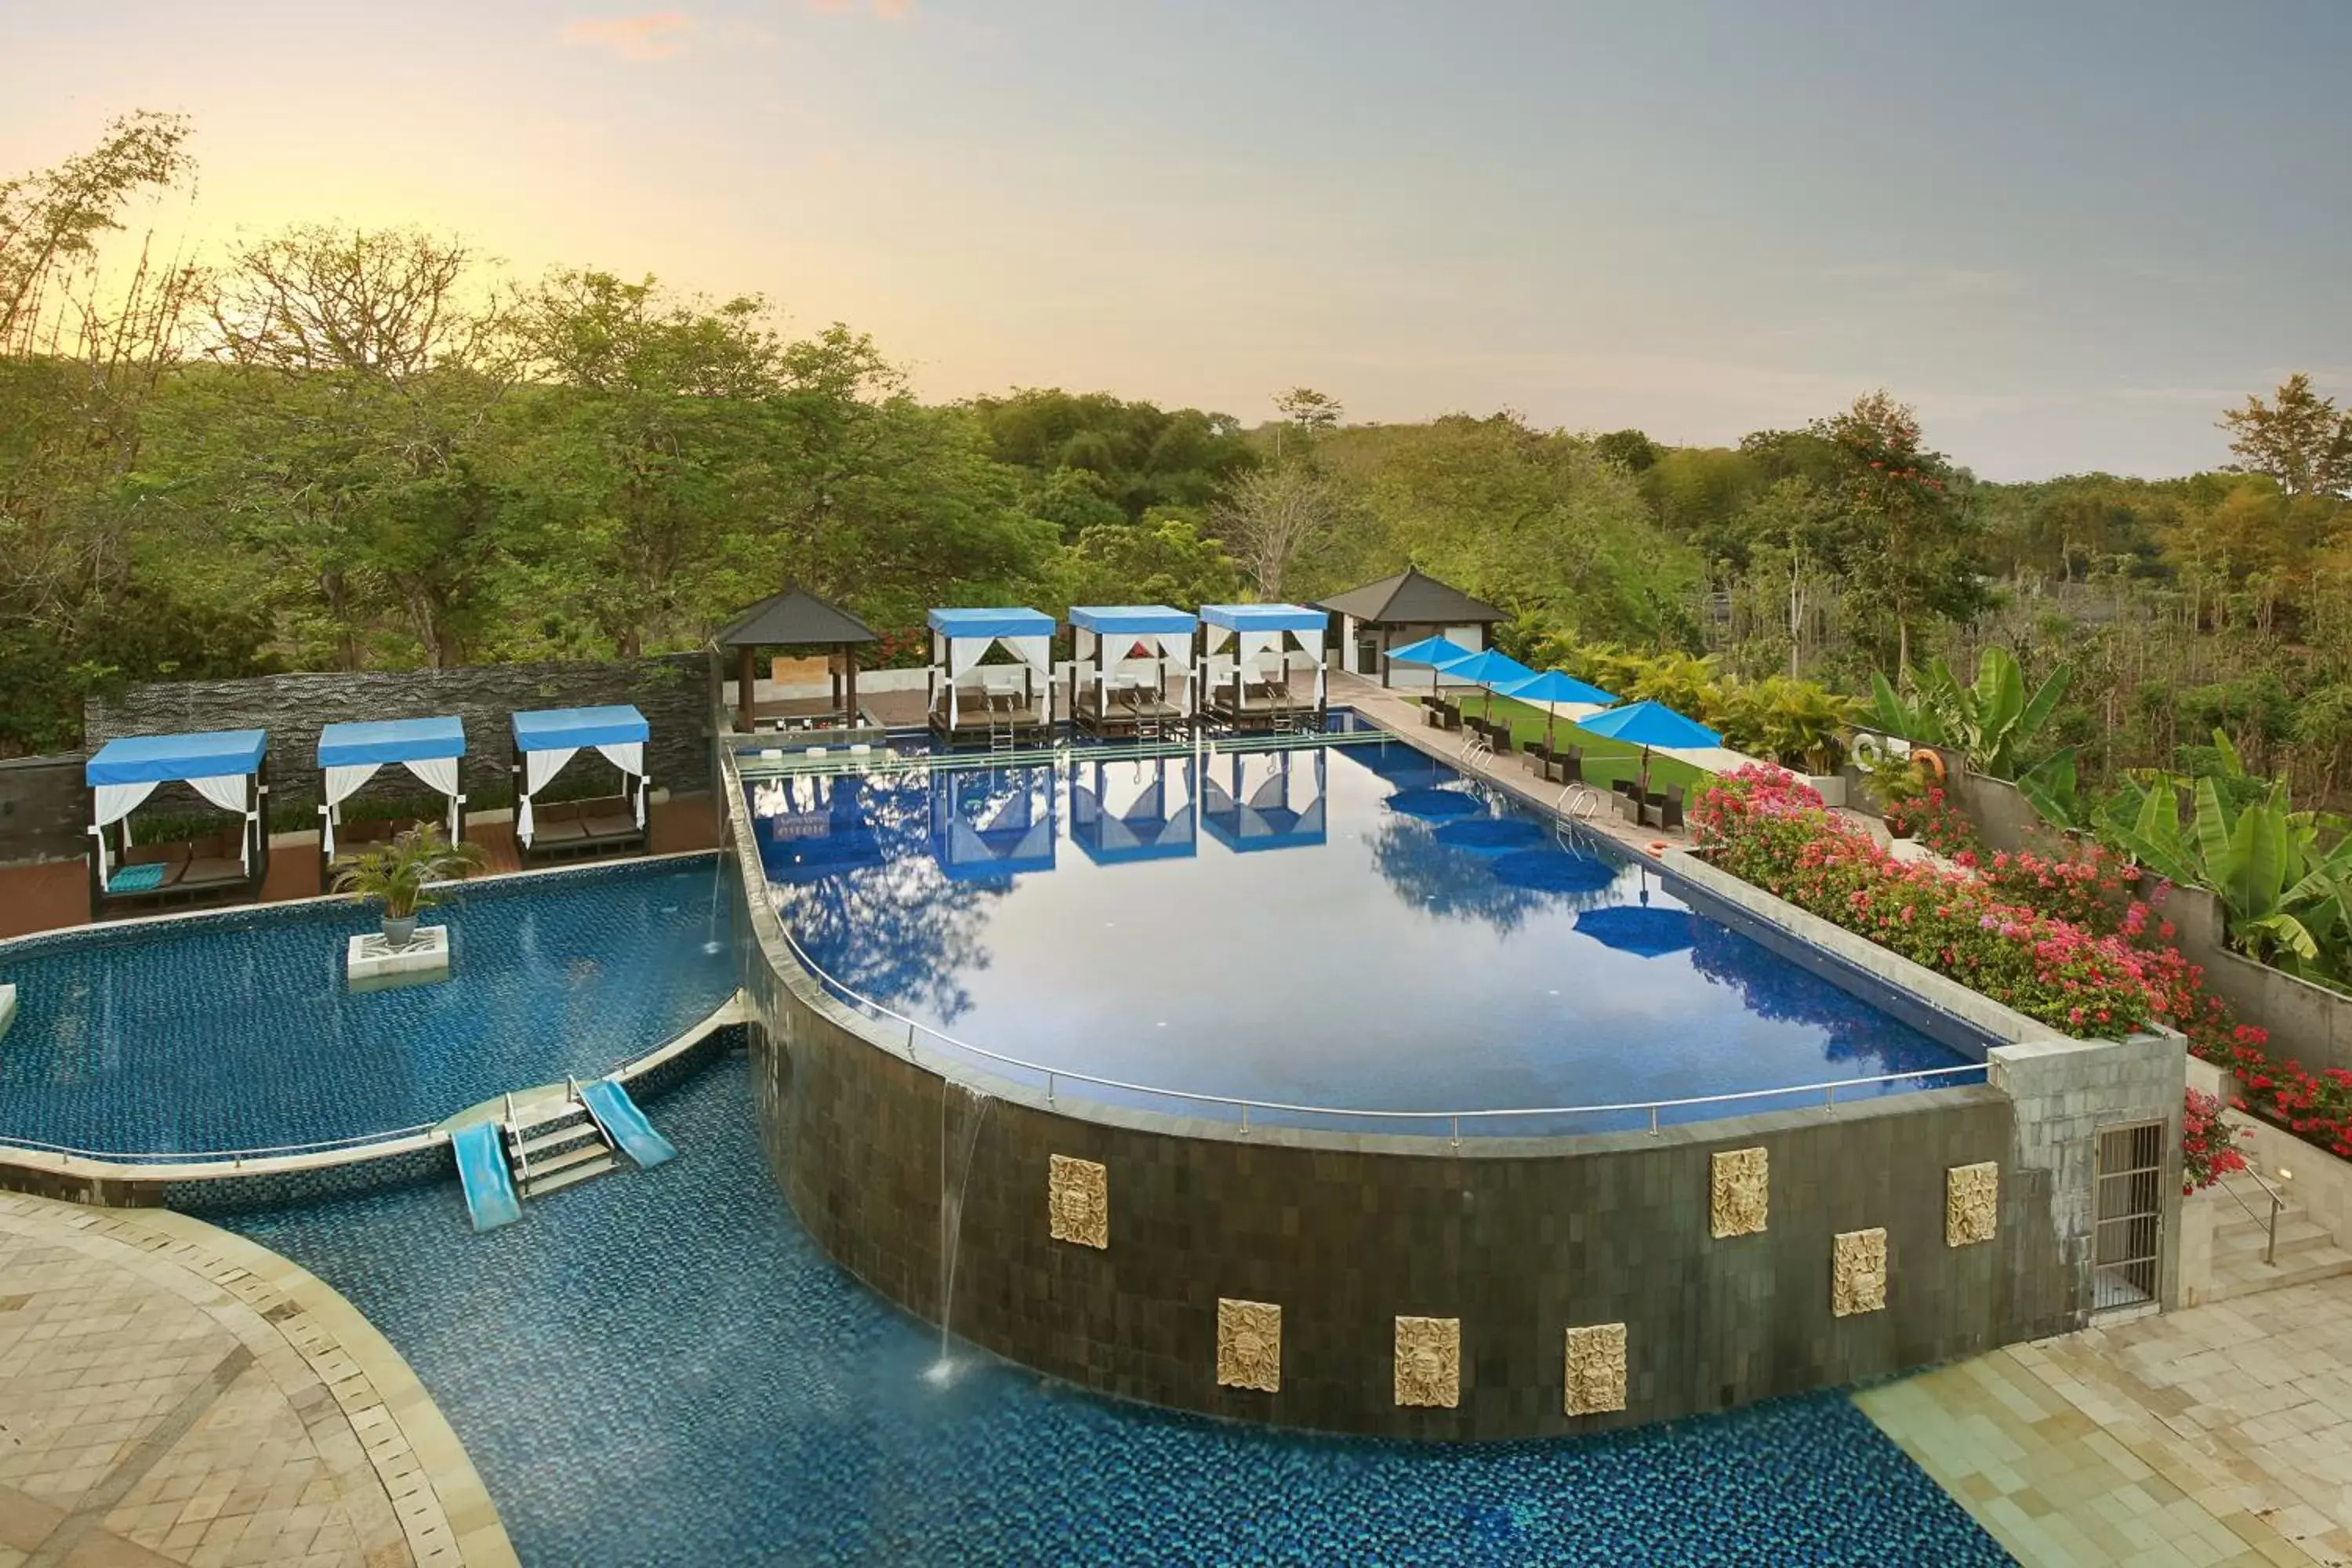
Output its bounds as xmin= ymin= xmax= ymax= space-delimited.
xmin=0 ymin=1192 xmax=515 ymax=1568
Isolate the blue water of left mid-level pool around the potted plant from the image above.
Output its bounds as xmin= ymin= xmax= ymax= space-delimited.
xmin=0 ymin=855 xmax=736 ymax=1154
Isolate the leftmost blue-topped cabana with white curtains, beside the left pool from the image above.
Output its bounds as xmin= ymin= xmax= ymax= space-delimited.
xmin=82 ymin=729 xmax=270 ymax=916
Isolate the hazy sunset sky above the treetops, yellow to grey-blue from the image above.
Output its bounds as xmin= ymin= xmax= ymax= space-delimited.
xmin=0 ymin=0 xmax=2352 ymax=477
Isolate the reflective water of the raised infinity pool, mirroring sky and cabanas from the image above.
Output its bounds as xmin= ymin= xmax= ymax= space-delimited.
xmin=746 ymin=741 xmax=1969 ymax=1133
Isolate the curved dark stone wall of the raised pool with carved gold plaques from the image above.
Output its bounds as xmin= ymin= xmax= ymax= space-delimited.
xmin=722 ymin=752 xmax=2180 ymax=1439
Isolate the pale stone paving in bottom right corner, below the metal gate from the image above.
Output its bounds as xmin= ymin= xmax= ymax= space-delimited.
xmin=1856 ymin=1276 xmax=2352 ymax=1568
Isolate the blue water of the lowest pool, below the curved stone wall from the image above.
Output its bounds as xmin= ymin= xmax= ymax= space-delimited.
xmin=221 ymin=1055 xmax=2009 ymax=1568
